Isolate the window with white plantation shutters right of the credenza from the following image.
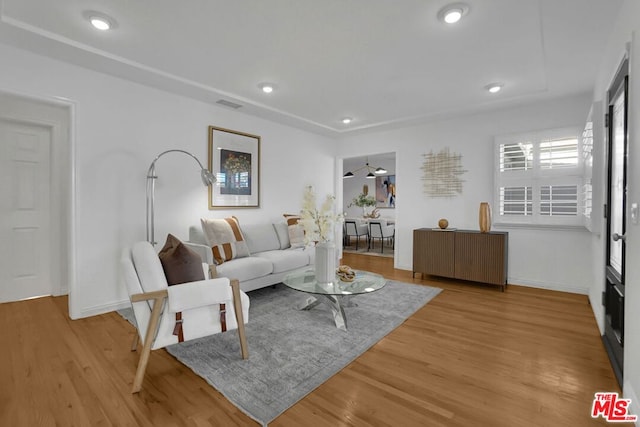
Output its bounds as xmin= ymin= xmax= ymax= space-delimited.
xmin=495 ymin=128 xmax=584 ymax=226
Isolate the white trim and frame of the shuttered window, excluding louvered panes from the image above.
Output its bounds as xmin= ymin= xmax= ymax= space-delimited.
xmin=493 ymin=126 xmax=585 ymax=230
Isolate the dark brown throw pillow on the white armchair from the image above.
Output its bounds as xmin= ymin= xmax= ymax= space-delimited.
xmin=158 ymin=234 xmax=204 ymax=286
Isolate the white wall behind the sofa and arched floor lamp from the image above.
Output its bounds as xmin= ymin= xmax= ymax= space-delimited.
xmin=0 ymin=44 xmax=335 ymax=317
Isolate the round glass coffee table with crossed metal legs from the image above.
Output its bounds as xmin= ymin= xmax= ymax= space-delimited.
xmin=282 ymin=268 xmax=387 ymax=331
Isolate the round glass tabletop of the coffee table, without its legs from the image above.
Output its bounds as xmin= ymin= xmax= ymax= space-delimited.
xmin=282 ymin=268 xmax=387 ymax=295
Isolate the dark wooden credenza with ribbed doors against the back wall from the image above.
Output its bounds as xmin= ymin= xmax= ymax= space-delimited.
xmin=413 ymin=228 xmax=509 ymax=291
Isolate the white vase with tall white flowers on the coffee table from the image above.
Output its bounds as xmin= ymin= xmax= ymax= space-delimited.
xmin=298 ymin=186 xmax=342 ymax=283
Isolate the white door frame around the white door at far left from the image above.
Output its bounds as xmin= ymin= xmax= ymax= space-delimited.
xmin=0 ymin=88 xmax=80 ymax=319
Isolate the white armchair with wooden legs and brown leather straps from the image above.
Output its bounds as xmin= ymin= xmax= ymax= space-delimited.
xmin=121 ymin=242 xmax=249 ymax=393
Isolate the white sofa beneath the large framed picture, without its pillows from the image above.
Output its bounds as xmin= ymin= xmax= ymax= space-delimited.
xmin=184 ymin=222 xmax=315 ymax=292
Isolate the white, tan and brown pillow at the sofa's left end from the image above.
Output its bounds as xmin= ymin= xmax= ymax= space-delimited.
xmin=200 ymin=217 xmax=249 ymax=264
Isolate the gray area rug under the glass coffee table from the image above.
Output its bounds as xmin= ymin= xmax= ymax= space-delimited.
xmin=120 ymin=281 xmax=441 ymax=426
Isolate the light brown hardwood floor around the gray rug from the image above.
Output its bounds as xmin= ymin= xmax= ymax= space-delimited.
xmin=0 ymin=254 xmax=620 ymax=427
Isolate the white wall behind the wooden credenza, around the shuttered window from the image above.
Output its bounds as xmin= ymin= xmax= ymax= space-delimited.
xmin=338 ymin=94 xmax=592 ymax=294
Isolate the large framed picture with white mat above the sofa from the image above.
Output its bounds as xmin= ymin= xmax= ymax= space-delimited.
xmin=209 ymin=126 xmax=260 ymax=209
